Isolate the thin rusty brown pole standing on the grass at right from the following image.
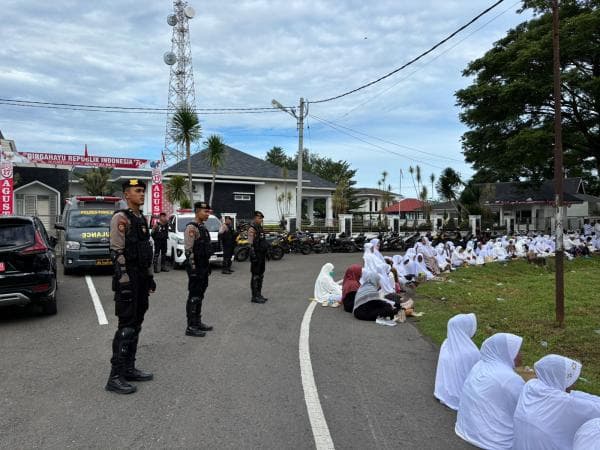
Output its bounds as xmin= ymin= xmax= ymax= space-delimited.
xmin=552 ymin=0 xmax=565 ymax=327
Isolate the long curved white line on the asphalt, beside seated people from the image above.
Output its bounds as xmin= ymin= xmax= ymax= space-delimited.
xmin=298 ymin=302 xmax=335 ymax=450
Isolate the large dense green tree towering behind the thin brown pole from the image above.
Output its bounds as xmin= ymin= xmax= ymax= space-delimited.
xmin=456 ymin=0 xmax=600 ymax=193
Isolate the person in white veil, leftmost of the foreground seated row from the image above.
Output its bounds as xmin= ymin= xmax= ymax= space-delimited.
xmin=433 ymin=313 xmax=480 ymax=411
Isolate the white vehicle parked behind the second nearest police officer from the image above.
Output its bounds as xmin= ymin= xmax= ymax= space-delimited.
xmin=167 ymin=209 xmax=223 ymax=268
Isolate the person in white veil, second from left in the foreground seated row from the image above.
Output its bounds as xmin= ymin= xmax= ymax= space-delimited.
xmin=454 ymin=333 xmax=525 ymax=449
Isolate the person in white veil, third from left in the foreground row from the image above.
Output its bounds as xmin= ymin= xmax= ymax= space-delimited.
xmin=513 ymin=355 xmax=600 ymax=450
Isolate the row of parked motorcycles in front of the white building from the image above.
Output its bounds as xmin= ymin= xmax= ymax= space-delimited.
xmin=233 ymin=231 xmax=420 ymax=261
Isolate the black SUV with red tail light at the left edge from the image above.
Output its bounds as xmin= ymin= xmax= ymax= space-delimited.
xmin=0 ymin=216 xmax=57 ymax=314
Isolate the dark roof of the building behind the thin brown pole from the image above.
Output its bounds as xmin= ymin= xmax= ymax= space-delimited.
xmin=479 ymin=178 xmax=587 ymax=203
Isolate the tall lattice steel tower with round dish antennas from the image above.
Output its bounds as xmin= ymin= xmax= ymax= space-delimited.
xmin=163 ymin=0 xmax=196 ymax=161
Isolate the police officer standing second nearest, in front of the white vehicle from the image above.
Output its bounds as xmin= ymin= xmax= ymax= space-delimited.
xmin=184 ymin=202 xmax=213 ymax=337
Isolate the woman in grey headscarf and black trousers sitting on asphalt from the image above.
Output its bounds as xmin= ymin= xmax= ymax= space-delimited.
xmin=353 ymin=270 xmax=398 ymax=326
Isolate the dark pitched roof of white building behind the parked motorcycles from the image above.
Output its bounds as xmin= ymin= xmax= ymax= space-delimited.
xmin=164 ymin=145 xmax=336 ymax=189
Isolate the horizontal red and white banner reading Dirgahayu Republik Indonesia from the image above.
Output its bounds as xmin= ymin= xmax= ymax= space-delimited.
xmin=18 ymin=152 xmax=148 ymax=169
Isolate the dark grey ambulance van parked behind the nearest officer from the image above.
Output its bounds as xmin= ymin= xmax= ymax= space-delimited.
xmin=54 ymin=196 xmax=122 ymax=275
